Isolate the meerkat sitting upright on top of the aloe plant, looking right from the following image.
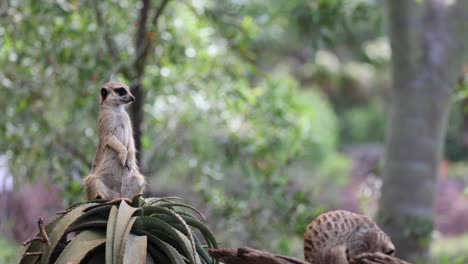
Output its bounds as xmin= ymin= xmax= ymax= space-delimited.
xmin=84 ymin=82 xmax=145 ymax=200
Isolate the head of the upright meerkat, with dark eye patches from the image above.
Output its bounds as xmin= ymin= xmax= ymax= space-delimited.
xmin=101 ymin=82 xmax=135 ymax=106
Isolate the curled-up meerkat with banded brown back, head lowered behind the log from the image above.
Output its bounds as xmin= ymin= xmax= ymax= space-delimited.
xmin=304 ymin=210 xmax=395 ymax=264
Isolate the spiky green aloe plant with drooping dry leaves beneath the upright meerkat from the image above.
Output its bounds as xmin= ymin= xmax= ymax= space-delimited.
xmin=20 ymin=196 xmax=218 ymax=264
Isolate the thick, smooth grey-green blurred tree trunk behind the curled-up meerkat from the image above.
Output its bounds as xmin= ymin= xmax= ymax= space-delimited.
xmin=378 ymin=0 xmax=468 ymax=260
